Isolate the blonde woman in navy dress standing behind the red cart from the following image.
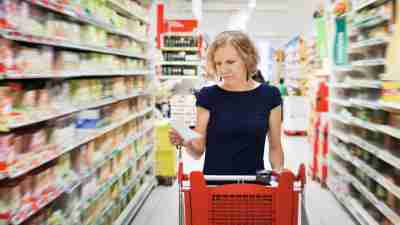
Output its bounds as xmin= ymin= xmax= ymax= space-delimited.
xmin=170 ymin=31 xmax=284 ymax=175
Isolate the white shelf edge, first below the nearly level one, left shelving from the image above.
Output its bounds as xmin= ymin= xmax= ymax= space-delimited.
xmin=7 ymin=89 xmax=149 ymax=129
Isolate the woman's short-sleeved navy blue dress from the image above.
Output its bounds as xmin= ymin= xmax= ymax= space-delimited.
xmin=196 ymin=84 xmax=282 ymax=175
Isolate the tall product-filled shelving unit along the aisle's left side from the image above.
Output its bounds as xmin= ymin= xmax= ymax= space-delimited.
xmin=0 ymin=0 xmax=156 ymax=225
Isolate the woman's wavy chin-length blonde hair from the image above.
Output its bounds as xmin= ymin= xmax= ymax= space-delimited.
xmin=207 ymin=31 xmax=260 ymax=75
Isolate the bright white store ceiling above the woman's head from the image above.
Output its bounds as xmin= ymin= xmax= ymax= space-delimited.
xmin=164 ymin=0 xmax=318 ymax=46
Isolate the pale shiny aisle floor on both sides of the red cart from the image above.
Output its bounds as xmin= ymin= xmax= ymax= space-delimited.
xmin=131 ymin=137 xmax=356 ymax=225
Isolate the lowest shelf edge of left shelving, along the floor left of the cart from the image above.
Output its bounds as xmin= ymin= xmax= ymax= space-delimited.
xmin=113 ymin=178 xmax=156 ymax=225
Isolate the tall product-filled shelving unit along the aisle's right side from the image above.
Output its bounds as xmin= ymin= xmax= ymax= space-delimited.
xmin=328 ymin=0 xmax=400 ymax=224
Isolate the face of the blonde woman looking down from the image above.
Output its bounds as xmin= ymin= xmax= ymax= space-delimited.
xmin=214 ymin=44 xmax=247 ymax=83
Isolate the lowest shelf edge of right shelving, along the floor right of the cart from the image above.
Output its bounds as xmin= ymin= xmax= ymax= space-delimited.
xmin=328 ymin=164 xmax=379 ymax=225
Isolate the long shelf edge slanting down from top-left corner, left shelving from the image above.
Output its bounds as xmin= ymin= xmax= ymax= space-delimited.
xmin=25 ymin=0 xmax=148 ymax=43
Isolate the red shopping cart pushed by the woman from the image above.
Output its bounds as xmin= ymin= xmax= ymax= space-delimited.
xmin=178 ymin=147 xmax=308 ymax=225
